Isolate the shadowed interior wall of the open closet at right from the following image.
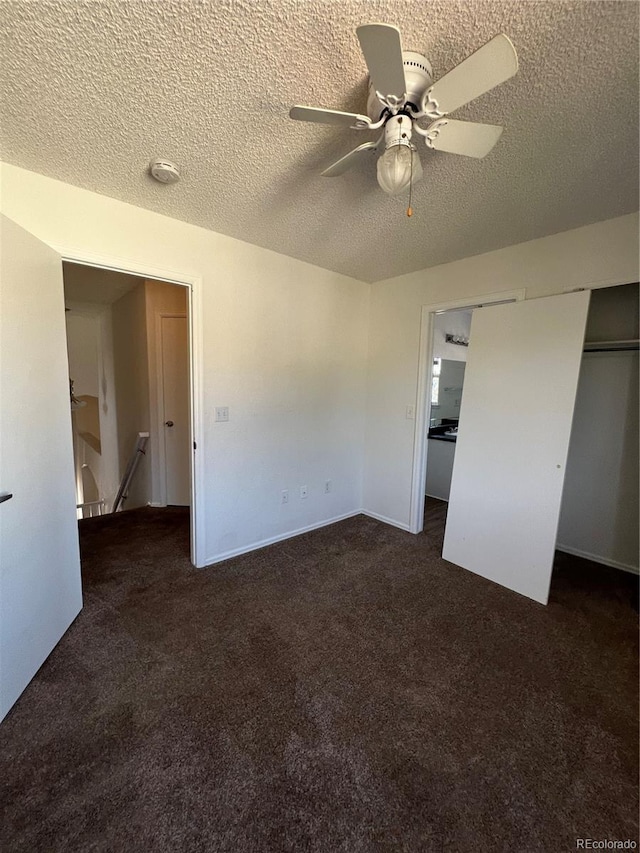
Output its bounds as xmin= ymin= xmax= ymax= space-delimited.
xmin=558 ymin=284 xmax=640 ymax=572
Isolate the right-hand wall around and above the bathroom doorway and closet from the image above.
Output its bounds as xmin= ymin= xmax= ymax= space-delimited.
xmin=364 ymin=214 xmax=638 ymax=527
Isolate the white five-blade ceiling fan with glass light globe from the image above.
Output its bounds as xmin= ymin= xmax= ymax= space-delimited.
xmin=289 ymin=24 xmax=518 ymax=198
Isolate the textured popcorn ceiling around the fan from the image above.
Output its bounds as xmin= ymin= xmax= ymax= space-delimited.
xmin=0 ymin=0 xmax=639 ymax=281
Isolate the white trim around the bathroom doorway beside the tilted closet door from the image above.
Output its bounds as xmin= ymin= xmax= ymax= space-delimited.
xmin=410 ymin=288 xmax=525 ymax=533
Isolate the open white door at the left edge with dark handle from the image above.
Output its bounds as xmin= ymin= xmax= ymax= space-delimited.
xmin=0 ymin=216 xmax=82 ymax=719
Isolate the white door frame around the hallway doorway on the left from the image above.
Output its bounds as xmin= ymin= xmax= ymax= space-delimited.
xmin=49 ymin=244 xmax=206 ymax=568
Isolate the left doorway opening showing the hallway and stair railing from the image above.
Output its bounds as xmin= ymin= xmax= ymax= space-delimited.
xmin=63 ymin=261 xmax=196 ymax=565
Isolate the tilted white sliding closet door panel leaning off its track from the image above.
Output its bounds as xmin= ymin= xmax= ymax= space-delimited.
xmin=442 ymin=291 xmax=590 ymax=604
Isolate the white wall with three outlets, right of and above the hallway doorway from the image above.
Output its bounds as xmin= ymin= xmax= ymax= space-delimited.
xmin=0 ymin=164 xmax=369 ymax=562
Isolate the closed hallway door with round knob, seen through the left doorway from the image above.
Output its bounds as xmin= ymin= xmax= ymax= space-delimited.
xmin=161 ymin=317 xmax=191 ymax=506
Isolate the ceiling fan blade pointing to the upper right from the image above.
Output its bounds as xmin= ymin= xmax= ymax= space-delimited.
xmin=429 ymin=33 xmax=518 ymax=114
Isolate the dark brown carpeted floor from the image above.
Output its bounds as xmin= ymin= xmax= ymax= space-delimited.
xmin=0 ymin=502 xmax=638 ymax=853
